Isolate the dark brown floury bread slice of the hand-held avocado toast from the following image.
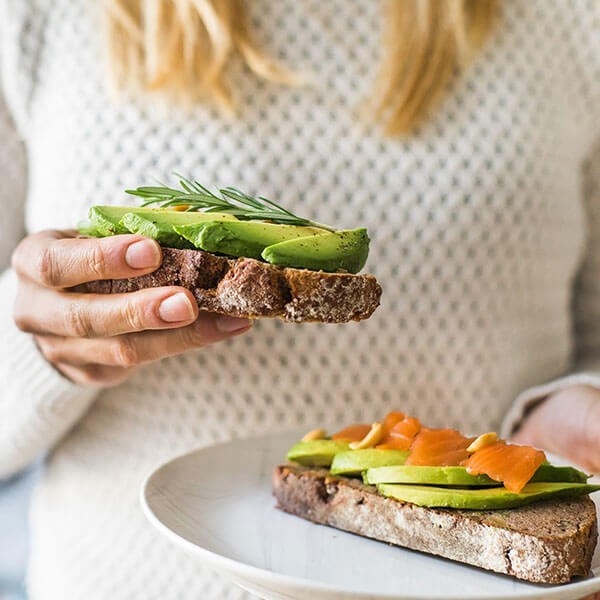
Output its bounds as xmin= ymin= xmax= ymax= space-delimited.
xmin=83 ymin=248 xmax=381 ymax=323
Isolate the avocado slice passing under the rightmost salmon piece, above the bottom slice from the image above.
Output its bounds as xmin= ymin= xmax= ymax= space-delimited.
xmin=364 ymin=464 xmax=588 ymax=487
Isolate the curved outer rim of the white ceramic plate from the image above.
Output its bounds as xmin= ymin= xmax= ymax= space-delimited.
xmin=139 ymin=430 xmax=600 ymax=600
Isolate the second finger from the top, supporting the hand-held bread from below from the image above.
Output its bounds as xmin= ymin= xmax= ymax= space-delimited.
xmin=13 ymin=282 xmax=198 ymax=338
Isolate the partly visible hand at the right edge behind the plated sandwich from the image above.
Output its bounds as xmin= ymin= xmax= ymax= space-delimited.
xmin=513 ymin=385 xmax=600 ymax=473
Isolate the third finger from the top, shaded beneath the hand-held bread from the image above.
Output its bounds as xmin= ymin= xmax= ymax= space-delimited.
xmin=36 ymin=314 xmax=251 ymax=370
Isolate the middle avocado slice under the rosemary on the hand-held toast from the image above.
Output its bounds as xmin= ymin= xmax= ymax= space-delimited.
xmin=175 ymin=218 xmax=327 ymax=258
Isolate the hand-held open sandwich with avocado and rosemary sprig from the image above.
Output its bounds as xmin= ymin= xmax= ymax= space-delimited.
xmin=79 ymin=178 xmax=381 ymax=323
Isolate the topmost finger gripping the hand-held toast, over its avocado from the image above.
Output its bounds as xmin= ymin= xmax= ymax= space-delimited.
xmin=12 ymin=231 xmax=162 ymax=289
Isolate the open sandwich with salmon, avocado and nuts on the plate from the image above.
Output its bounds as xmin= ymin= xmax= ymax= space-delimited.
xmin=273 ymin=412 xmax=600 ymax=584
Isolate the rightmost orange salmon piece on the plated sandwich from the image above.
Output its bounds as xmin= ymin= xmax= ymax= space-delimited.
xmin=466 ymin=441 xmax=546 ymax=494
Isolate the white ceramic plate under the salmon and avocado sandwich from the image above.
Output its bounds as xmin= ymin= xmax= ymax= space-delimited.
xmin=141 ymin=434 xmax=600 ymax=600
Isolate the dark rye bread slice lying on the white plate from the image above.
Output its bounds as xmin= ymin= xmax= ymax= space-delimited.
xmin=273 ymin=465 xmax=598 ymax=584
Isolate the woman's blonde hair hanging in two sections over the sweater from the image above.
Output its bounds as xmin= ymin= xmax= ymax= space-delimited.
xmin=104 ymin=0 xmax=497 ymax=135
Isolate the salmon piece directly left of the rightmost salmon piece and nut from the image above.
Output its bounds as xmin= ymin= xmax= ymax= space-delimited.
xmin=406 ymin=427 xmax=474 ymax=467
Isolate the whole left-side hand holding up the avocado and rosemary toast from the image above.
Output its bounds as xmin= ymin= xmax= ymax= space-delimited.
xmin=12 ymin=231 xmax=250 ymax=387
